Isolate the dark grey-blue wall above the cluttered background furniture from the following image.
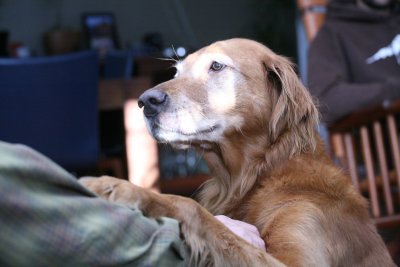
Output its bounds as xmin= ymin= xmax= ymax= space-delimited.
xmin=0 ymin=0 xmax=255 ymax=54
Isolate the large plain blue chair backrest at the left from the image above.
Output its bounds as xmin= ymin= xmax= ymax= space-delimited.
xmin=0 ymin=51 xmax=99 ymax=171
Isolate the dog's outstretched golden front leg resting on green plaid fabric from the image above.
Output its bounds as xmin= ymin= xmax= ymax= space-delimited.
xmin=81 ymin=177 xmax=284 ymax=266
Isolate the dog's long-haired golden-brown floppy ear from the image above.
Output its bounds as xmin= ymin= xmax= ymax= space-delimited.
xmin=264 ymin=54 xmax=319 ymax=153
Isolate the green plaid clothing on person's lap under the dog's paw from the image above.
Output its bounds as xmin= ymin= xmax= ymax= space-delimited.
xmin=0 ymin=142 xmax=186 ymax=267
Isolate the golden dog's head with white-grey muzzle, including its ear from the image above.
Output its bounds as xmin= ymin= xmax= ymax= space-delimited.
xmin=139 ymin=39 xmax=318 ymax=154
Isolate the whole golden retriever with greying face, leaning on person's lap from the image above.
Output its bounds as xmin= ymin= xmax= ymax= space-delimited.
xmin=83 ymin=39 xmax=395 ymax=267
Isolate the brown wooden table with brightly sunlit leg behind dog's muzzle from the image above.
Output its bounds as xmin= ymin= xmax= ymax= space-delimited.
xmin=98 ymin=76 xmax=160 ymax=192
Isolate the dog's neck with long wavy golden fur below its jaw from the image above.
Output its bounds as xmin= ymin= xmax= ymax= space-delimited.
xmin=198 ymin=126 xmax=324 ymax=215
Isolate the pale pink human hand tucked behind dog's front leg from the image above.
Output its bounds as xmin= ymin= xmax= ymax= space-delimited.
xmin=215 ymin=215 xmax=266 ymax=250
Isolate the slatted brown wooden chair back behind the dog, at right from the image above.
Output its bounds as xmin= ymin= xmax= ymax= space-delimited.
xmin=329 ymin=101 xmax=400 ymax=227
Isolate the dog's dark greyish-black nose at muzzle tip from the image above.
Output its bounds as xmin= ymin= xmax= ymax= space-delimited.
xmin=138 ymin=89 xmax=168 ymax=117
